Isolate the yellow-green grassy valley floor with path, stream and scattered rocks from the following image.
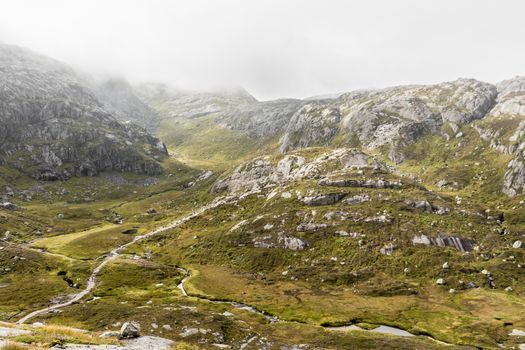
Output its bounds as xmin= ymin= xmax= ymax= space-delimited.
xmin=0 ymin=144 xmax=525 ymax=349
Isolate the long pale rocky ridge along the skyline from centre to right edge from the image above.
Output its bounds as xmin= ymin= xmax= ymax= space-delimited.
xmin=140 ymin=77 xmax=525 ymax=196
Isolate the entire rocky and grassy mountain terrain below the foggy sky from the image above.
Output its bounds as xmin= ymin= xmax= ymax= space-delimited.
xmin=5 ymin=45 xmax=525 ymax=350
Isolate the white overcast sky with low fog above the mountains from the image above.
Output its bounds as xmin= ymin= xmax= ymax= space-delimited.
xmin=0 ymin=0 xmax=525 ymax=99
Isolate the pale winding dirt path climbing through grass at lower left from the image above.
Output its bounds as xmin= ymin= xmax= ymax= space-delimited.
xmin=17 ymin=196 xmax=237 ymax=324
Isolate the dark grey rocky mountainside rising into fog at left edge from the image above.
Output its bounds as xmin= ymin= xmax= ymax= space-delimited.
xmin=0 ymin=44 xmax=166 ymax=180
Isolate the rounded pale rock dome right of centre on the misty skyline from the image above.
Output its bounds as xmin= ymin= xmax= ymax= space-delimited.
xmin=280 ymin=79 xmax=497 ymax=162
